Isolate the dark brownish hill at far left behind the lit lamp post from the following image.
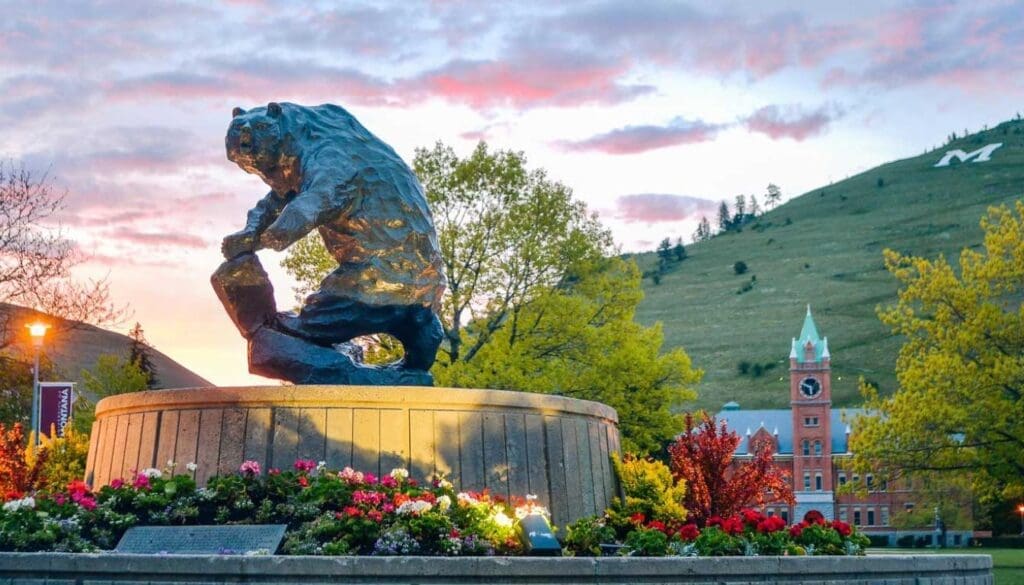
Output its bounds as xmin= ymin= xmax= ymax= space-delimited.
xmin=0 ymin=303 xmax=213 ymax=388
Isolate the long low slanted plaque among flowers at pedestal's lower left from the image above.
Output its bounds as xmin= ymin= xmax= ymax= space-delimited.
xmin=114 ymin=525 xmax=288 ymax=554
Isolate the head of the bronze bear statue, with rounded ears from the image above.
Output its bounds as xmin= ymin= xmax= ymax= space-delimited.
xmin=224 ymin=101 xmax=289 ymax=186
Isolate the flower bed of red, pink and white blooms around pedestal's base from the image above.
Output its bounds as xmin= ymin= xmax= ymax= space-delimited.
xmin=0 ymin=460 xmax=866 ymax=556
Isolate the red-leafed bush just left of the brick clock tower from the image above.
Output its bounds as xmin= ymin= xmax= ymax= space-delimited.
xmin=669 ymin=415 xmax=795 ymax=529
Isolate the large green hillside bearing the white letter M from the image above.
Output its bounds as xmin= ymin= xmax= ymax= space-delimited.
xmin=637 ymin=121 xmax=1024 ymax=410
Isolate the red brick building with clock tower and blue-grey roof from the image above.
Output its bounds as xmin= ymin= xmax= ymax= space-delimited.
xmin=716 ymin=306 xmax=914 ymax=533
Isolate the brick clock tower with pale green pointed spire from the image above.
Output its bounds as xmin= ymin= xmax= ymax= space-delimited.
xmin=790 ymin=305 xmax=836 ymax=523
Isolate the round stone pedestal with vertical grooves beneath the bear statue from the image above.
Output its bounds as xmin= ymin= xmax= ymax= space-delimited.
xmin=86 ymin=386 xmax=620 ymax=526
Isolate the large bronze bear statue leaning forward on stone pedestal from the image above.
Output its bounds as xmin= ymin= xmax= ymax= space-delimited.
xmin=211 ymin=102 xmax=445 ymax=385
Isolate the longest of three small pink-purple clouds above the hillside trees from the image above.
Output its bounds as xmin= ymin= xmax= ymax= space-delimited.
xmin=555 ymin=118 xmax=726 ymax=155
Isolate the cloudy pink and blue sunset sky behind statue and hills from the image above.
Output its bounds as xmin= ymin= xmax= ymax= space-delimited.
xmin=0 ymin=0 xmax=1024 ymax=385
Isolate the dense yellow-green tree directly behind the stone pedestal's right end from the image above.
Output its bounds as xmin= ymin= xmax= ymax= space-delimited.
xmin=433 ymin=258 xmax=702 ymax=453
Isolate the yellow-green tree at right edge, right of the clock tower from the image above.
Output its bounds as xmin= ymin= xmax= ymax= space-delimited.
xmin=851 ymin=202 xmax=1024 ymax=496
